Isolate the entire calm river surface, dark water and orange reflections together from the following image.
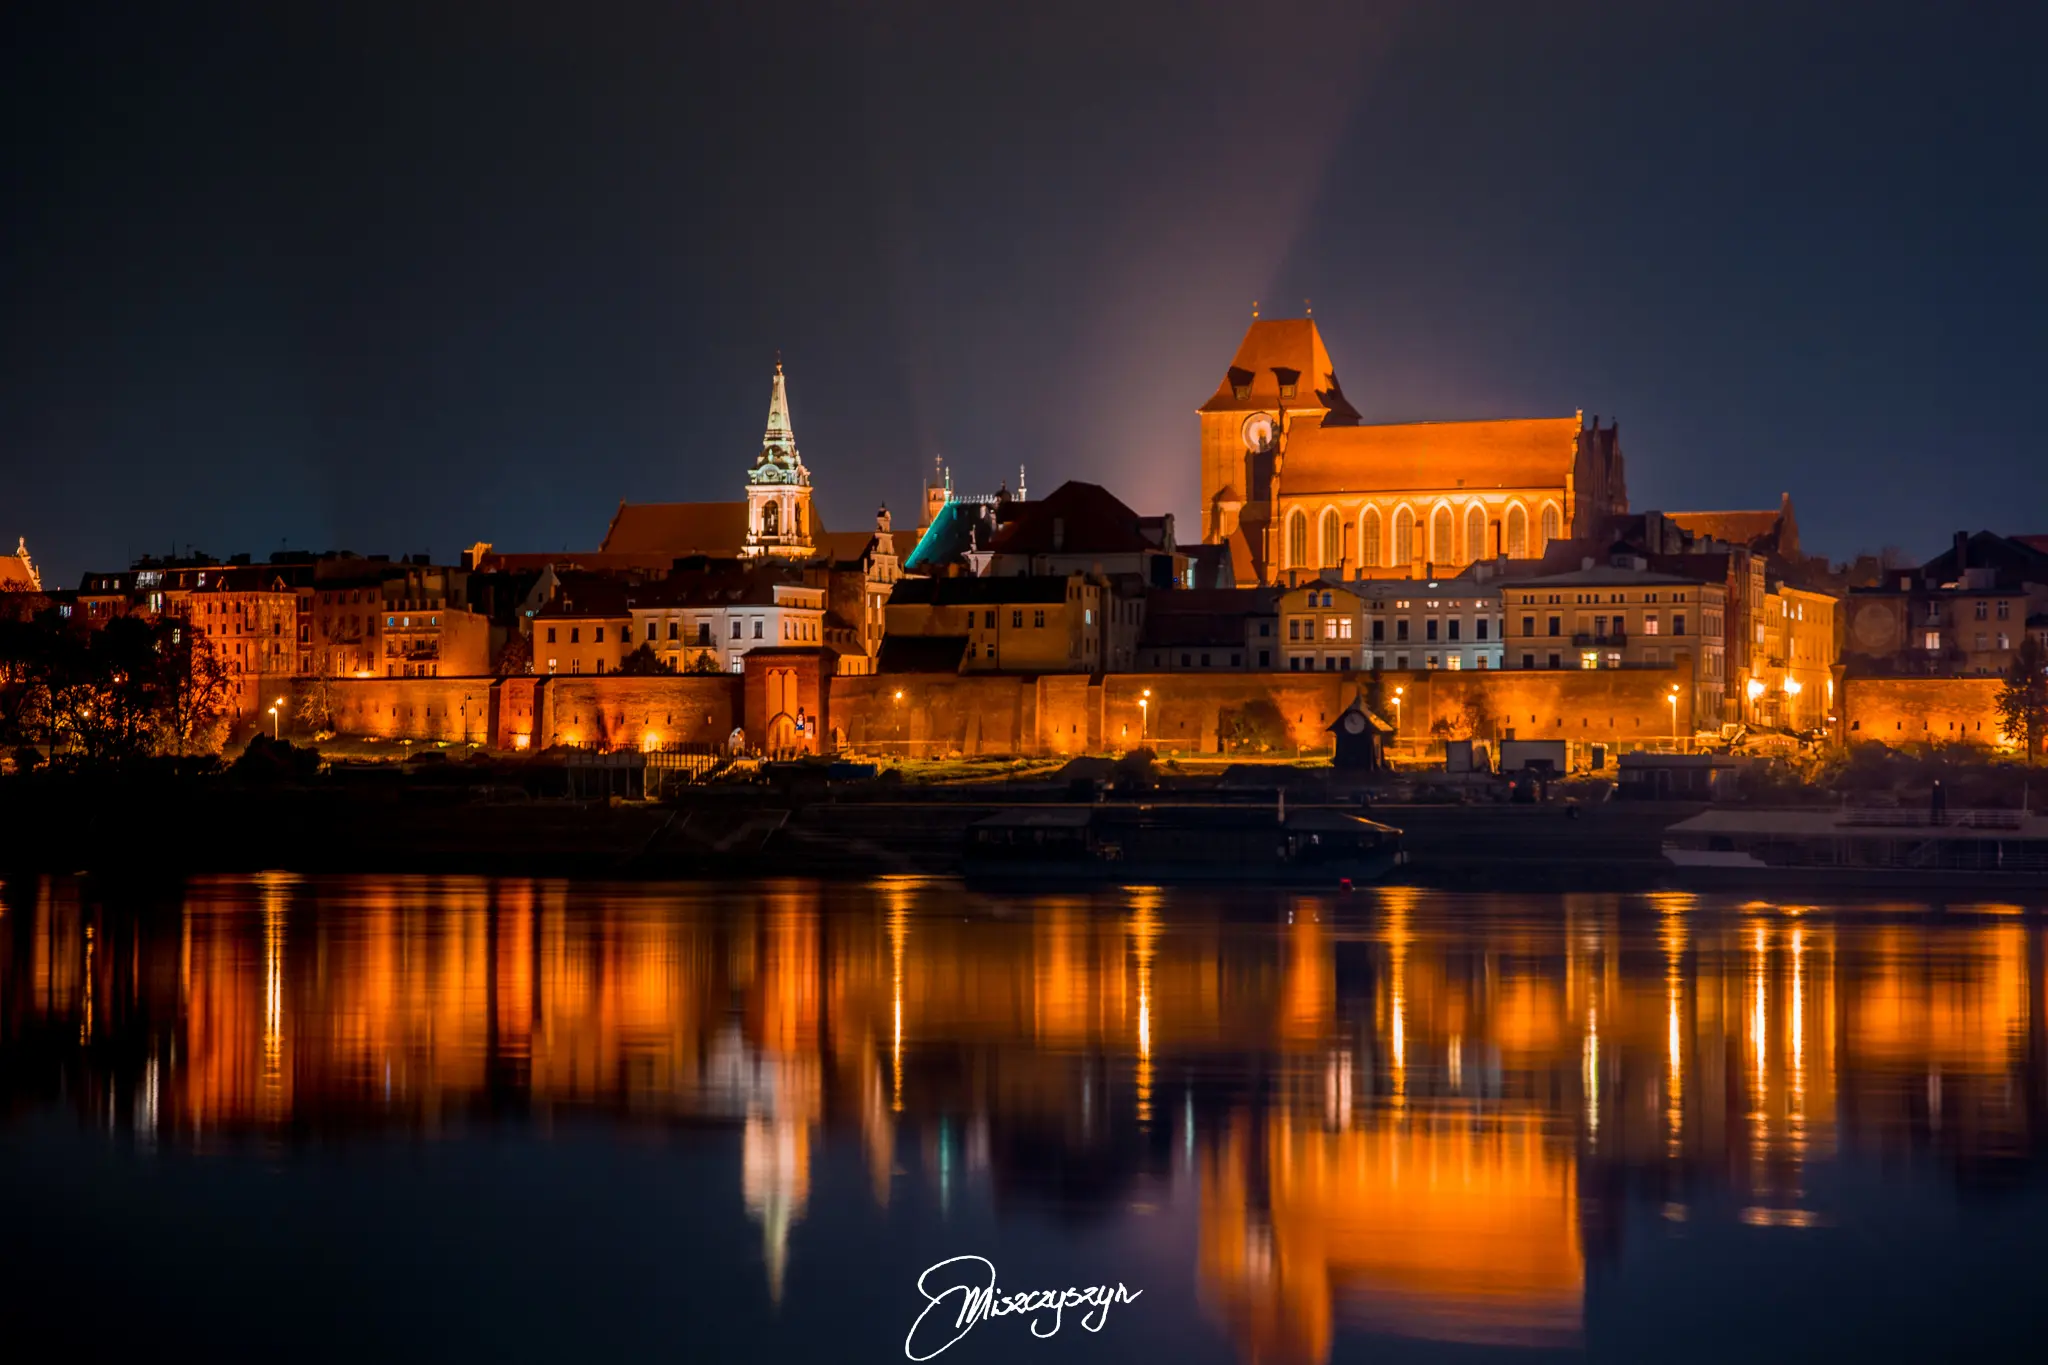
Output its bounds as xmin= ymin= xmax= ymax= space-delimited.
xmin=0 ymin=876 xmax=2048 ymax=1365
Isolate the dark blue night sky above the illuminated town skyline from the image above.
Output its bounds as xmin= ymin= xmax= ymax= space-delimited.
xmin=0 ymin=0 xmax=2048 ymax=585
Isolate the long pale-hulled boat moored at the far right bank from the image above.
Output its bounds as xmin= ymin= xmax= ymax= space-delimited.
xmin=1663 ymin=808 xmax=2048 ymax=890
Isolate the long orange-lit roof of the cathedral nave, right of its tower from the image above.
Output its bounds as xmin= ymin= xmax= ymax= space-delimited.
xmin=1280 ymin=415 xmax=1583 ymax=501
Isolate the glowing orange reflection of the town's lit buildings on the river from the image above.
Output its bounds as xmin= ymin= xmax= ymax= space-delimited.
xmin=0 ymin=876 xmax=2048 ymax=1361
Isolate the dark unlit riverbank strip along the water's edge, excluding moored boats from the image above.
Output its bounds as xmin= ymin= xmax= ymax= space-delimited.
xmin=0 ymin=784 xmax=1698 ymax=890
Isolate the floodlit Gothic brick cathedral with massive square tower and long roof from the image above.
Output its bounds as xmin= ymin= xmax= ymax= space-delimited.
xmin=1198 ymin=317 xmax=1628 ymax=583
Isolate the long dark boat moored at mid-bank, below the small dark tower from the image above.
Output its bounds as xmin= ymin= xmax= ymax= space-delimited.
xmin=963 ymin=804 xmax=1405 ymax=888
